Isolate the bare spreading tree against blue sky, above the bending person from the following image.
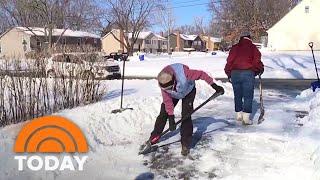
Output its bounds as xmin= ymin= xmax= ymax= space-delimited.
xmin=105 ymin=0 xmax=161 ymax=55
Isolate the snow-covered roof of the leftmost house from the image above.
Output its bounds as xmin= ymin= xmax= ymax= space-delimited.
xmin=15 ymin=27 xmax=100 ymax=38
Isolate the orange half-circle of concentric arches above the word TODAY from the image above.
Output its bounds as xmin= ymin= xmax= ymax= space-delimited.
xmin=14 ymin=116 xmax=88 ymax=153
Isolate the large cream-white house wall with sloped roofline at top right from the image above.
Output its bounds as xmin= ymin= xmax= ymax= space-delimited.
xmin=267 ymin=0 xmax=320 ymax=51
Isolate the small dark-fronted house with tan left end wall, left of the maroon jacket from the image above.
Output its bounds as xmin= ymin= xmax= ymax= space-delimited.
xmin=169 ymin=32 xmax=206 ymax=51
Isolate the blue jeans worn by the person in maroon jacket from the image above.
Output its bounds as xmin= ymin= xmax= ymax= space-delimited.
xmin=231 ymin=70 xmax=254 ymax=113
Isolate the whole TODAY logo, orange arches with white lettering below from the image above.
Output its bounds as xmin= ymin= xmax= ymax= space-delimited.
xmin=14 ymin=116 xmax=88 ymax=171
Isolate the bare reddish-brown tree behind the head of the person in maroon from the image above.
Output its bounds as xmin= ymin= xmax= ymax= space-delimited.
xmin=209 ymin=0 xmax=299 ymax=43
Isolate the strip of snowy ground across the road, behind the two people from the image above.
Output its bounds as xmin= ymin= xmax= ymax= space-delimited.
xmin=126 ymin=51 xmax=320 ymax=79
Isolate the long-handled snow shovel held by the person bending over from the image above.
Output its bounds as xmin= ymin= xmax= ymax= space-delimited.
xmin=139 ymin=92 xmax=222 ymax=155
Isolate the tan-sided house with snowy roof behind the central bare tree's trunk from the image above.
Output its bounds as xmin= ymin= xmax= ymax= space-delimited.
xmin=102 ymin=29 xmax=167 ymax=54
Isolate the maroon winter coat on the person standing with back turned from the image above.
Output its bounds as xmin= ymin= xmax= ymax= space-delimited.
xmin=224 ymin=37 xmax=264 ymax=77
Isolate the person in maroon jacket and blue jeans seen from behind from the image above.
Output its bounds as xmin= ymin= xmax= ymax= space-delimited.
xmin=224 ymin=32 xmax=264 ymax=125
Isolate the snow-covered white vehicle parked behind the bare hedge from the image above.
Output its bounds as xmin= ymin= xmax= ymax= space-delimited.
xmin=46 ymin=53 xmax=121 ymax=79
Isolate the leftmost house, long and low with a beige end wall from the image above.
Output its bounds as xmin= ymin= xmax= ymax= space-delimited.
xmin=0 ymin=27 xmax=101 ymax=57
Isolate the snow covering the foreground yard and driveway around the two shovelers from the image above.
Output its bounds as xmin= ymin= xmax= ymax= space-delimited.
xmin=0 ymin=80 xmax=320 ymax=180
